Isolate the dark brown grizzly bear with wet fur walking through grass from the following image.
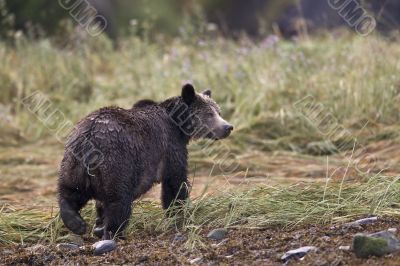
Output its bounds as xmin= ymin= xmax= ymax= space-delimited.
xmin=58 ymin=84 xmax=233 ymax=239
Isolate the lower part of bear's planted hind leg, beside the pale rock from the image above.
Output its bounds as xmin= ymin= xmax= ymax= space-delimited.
xmin=103 ymin=200 xmax=132 ymax=239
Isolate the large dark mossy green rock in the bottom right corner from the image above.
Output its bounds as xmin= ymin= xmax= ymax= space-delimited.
xmin=353 ymin=231 xmax=400 ymax=258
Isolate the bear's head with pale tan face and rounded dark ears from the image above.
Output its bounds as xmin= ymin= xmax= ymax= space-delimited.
xmin=181 ymin=84 xmax=233 ymax=140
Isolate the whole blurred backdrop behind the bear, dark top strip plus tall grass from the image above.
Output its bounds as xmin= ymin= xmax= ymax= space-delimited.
xmin=0 ymin=0 xmax=400 ymax=155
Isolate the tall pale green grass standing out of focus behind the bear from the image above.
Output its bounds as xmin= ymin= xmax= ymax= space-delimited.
xmin=0 ymin=36 xmax=400 ymax=153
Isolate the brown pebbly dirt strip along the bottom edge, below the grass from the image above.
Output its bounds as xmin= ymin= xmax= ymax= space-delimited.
xmin=0 ymin=217 xmax=400 ymax=265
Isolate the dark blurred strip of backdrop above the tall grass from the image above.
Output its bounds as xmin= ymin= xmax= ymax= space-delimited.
xmin=0 ymin=0 xmax=400 ymax=40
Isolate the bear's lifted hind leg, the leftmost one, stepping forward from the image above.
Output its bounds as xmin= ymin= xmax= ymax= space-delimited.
xmin=59 ymin=186 xmax=89 ymax=235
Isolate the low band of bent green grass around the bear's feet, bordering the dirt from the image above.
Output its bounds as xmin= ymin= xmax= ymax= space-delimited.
xmin=0 ymin=175 xmax=400 ymax=244
